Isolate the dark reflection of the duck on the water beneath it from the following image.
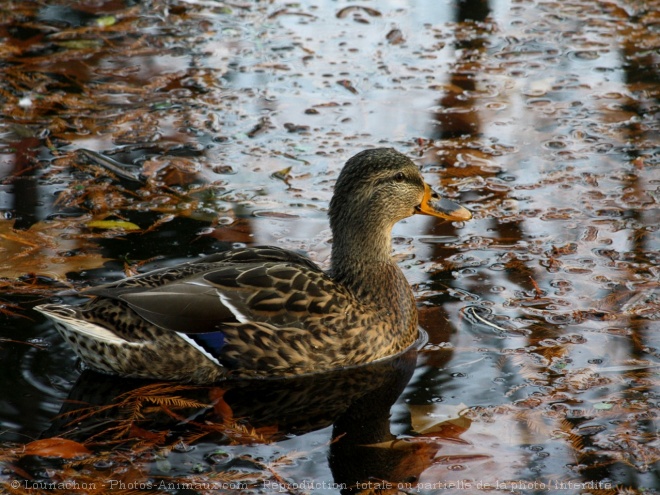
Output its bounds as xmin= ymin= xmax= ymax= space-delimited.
xmin=44 ymin=340 xmax=458 ymax=493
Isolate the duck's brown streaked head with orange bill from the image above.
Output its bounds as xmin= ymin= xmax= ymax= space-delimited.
xmin=329 ymin=148 xmax=472 ymax=235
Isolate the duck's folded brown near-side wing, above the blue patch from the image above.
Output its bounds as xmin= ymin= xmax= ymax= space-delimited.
xmin=84 ymin=250 xmax=353 ymax=334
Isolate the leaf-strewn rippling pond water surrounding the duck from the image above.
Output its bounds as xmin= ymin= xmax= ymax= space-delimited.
xmin=0 ymin=0 xmax=660 ymax=494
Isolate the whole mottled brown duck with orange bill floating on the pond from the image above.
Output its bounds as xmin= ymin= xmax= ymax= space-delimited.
xmin=35 ymin=148 xmax=471 ymax=383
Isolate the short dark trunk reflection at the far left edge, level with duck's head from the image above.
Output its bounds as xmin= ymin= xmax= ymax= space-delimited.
xmin=12 ymin=137 xmax=40 ymax=230
